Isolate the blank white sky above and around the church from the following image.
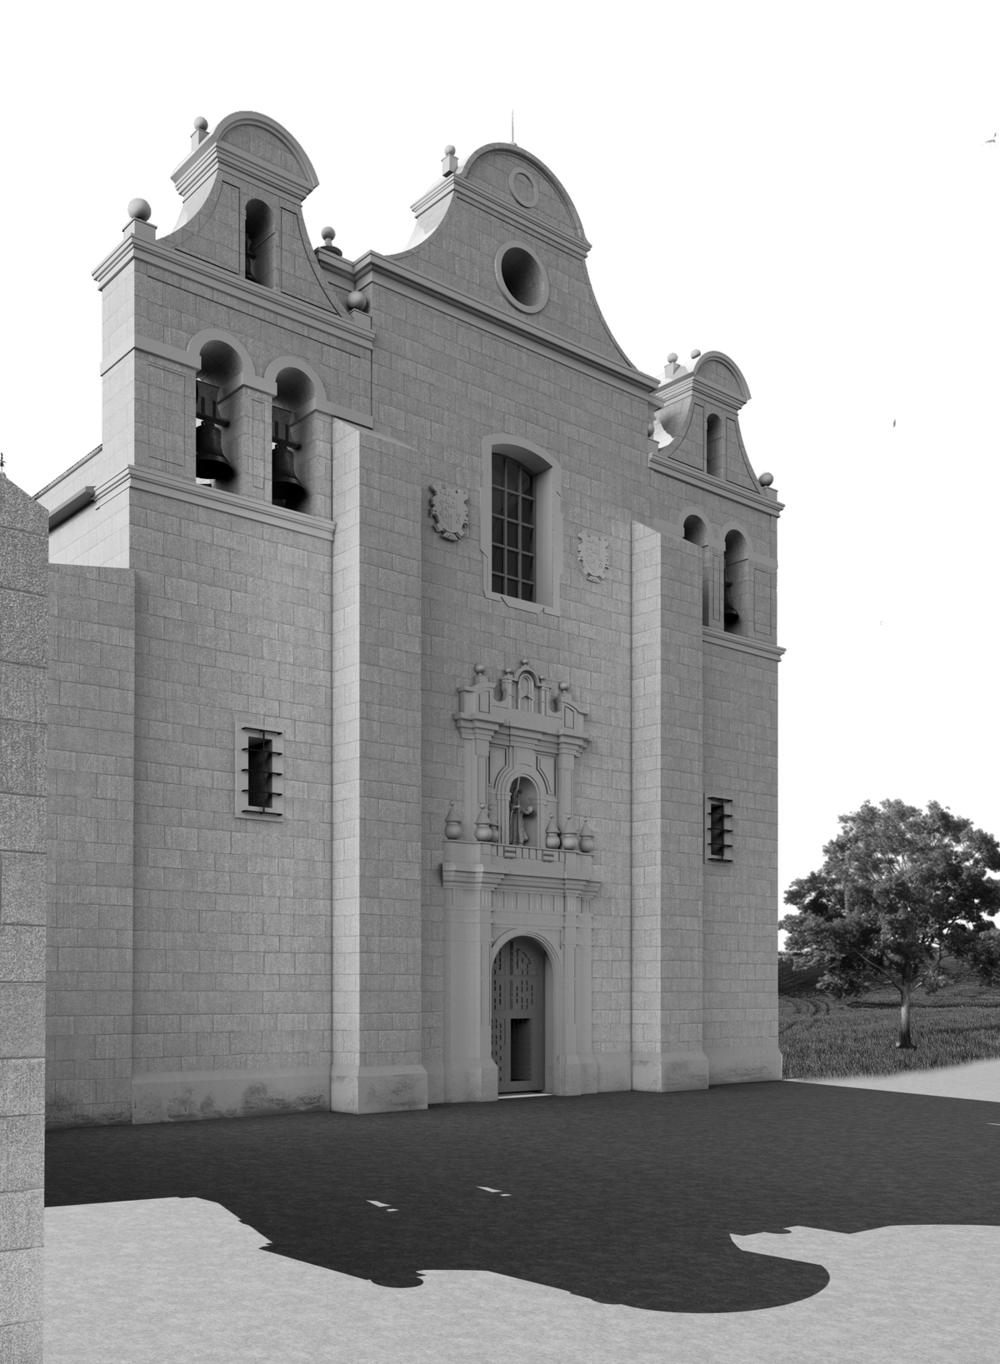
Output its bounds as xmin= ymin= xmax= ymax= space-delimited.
xmin=0 ymin=0 xmax=1000 ymax=949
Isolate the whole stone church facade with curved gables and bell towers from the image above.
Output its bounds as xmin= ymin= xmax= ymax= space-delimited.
xmin=31 ymin=113 xmax=782 ymax=1125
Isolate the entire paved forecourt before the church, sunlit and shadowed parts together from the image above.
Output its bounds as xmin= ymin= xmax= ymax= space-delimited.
xmin=40 ymin=1061 xmax=1000 ymax=1364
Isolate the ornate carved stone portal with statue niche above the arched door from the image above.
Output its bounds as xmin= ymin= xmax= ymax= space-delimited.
xmin=441 ymin=659 xmax=600 ymax=1102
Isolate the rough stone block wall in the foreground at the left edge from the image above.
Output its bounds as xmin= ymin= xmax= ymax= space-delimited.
xmin=0 ymin=472 xmax=49 ymax=1364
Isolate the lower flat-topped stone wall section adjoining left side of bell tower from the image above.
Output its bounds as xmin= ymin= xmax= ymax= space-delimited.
xmin=46 ymin=565 xmax=135 ymax=1127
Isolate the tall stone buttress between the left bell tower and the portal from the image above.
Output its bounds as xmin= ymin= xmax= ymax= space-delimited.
xmin=330 ymin=421 xmax=427 ymax=1113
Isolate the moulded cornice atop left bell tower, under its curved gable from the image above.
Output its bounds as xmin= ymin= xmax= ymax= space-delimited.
xmin=93 ymin=236 xmax=375 ymax=351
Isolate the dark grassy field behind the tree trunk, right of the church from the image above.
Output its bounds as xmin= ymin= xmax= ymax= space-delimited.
xmin=778 ymin=977 xmax=1000 ymax=1080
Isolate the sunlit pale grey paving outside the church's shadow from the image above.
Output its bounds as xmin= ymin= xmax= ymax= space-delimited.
xmin=45 ymin=1061 xmax=1000 ymax=1364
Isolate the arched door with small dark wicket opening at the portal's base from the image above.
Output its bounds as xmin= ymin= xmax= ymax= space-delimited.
xmin=492 ymin=937 xmax=546 ymax=1094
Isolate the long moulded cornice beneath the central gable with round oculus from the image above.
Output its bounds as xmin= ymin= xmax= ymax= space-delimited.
xmin=355 ymin=251 xmax=658 ymax=400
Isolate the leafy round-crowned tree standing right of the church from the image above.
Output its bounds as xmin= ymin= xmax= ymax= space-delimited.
xmin=780 ymin=801 xmax=1000 ymax=1048
